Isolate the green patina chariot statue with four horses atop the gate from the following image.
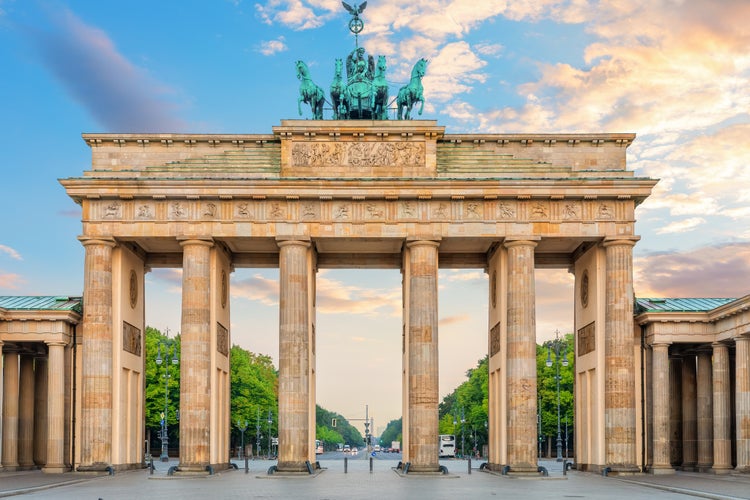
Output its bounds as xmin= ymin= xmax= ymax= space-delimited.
xmin=296 ymin=2 xmax=427 ymax=120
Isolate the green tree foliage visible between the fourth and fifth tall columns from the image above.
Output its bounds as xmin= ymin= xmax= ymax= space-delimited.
xmin=438 ymin=356 xmax=489 ymax=453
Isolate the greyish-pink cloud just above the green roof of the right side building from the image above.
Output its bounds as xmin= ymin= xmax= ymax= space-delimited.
xmin=634 ymin=243 xmax=750 ymax=298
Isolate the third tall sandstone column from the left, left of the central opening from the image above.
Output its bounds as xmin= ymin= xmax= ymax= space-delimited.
xmin=277 ymin=240 xmax=311 ymax=472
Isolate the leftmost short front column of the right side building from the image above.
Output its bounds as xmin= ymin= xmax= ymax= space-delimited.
xmin=651 ymin=343 xmax=674 ymax=474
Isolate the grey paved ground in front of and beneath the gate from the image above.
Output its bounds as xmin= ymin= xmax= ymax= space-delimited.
xmin=0 ymin=453 xmax=750 ymax=500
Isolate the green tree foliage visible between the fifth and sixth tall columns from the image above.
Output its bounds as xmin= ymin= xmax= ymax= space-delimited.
xmin=536 ymin=333 xmax=575 ymax=443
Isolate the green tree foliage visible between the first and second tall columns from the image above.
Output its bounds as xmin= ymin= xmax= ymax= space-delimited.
xmin=145 ymin=326 xmax=180 ymax=450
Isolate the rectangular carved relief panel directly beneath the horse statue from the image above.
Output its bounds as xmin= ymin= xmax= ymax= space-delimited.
xmin=292 ymin=142 xmax=425 ymax=167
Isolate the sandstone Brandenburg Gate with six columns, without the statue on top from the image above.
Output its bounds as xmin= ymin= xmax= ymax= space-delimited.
xmin=61 ymin=120 xmax=656 ymax=474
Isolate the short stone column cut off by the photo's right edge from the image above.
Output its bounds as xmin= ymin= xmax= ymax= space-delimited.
xmin=734 ymin=336 xmax=750 ymax=472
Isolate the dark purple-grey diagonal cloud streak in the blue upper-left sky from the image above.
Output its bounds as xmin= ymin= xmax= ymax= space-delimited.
xmin=26 ymin=4 xmax=186 ymax=132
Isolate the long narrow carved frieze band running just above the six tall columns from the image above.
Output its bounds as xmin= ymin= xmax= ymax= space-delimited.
xmin=91 ymin=198 xmax=628 ymax=223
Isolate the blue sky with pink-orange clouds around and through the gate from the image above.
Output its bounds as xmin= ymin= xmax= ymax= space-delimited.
xmin=0 ymin=0 xmax=750 ymax=430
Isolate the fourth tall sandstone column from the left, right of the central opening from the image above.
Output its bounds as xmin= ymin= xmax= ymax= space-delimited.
xmin=406 ymin=240 xmax=440 ymax=472
